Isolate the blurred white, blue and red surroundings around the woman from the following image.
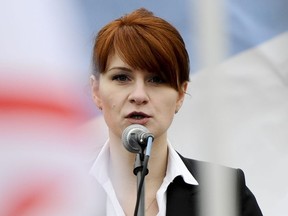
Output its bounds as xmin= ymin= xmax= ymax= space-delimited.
xmin=0 ymin=0 xmax=288 ymax=216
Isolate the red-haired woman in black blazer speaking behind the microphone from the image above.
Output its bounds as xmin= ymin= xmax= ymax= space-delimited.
xmin=91 ymin=8 xmax=262 ymax=215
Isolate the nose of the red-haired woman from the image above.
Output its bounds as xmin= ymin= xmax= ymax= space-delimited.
xmin=128 ymin=82 xmax=149 ymax=105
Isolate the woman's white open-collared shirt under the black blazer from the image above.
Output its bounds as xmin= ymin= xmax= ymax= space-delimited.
xmin=90 ymin=141 xmax=198 ymax=216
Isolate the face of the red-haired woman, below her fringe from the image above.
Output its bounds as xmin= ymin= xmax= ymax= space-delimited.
xmin=92 ymin=54 xmax=187 ymax=139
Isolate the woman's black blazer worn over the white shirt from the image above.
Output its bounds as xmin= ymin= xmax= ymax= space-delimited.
xmin=166 ymin=154 xmax=262 ymax=216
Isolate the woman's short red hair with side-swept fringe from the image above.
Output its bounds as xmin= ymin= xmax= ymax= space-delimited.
xmin=93 ymin=8 xmax=189 ymax=91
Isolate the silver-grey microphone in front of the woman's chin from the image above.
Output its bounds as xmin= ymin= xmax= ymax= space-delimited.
xmin=122 ymin=124 xmax=154 ymax=153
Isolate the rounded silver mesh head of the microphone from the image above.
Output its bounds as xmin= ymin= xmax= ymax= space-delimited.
xmin=122 ymin=124 xmax=149 ymax=153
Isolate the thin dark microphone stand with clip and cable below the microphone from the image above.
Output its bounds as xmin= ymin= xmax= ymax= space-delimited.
xmin=133 ymin=136 xmax=154 ymax=216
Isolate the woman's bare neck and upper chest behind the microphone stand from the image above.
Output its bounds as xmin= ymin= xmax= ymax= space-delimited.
xmin=109 ymin=134 xmax=168 ymax=215
